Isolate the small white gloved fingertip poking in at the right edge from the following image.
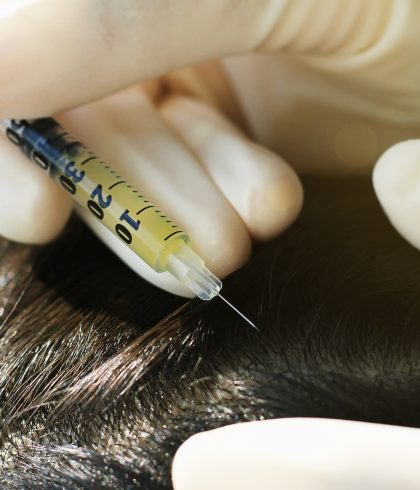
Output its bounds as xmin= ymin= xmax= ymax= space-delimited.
xmin=373 ymin=140 xmax=420 ymax=249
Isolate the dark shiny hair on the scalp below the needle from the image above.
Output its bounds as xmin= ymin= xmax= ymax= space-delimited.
xmin=0 ymin=178 xmax=420 ymax=489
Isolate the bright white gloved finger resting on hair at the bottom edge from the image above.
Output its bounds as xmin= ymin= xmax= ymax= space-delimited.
xmin=172 ymin=418 xmax=420 ymax=490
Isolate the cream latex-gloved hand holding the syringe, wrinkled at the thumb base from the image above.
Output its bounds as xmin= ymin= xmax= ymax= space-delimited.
xmin=0 ymin=0 xmax=420 ymax=293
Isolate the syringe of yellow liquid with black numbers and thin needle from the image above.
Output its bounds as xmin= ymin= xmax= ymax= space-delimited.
xmin=2 ymin=118 xmax=258 ymax=330
